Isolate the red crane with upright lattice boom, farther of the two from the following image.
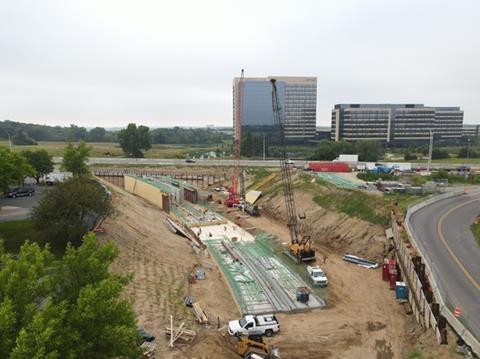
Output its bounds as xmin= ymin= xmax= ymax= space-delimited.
xmin=225 ymin=69 xmax=245 ymax=207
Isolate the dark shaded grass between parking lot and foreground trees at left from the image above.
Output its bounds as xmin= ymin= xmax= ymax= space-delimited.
xmin=0 ymin=220 xmax=66 ymax=257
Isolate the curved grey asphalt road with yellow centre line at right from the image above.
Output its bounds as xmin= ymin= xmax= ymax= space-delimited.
xmin=411 ymin=190 xmax=480 ymax=340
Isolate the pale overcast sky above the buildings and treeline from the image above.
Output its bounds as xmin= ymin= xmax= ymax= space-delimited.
xmin=0 ymin=0 xmax=480 ymax=127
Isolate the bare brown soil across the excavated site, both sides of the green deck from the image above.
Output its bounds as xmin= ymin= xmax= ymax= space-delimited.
xmin=100 ymin=180 xmax=449 ymax=359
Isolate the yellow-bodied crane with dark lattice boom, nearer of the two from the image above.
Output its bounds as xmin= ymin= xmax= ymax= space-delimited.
xmin=270 ymin=79 xmax=315 ymax=262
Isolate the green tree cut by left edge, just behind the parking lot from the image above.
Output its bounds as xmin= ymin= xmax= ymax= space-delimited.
xmin=0 ymin=146 xmax=35 ymax=192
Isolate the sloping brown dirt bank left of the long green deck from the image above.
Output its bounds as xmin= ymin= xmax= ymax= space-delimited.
xmin=98 ymin=186 xmax=240 ymax=358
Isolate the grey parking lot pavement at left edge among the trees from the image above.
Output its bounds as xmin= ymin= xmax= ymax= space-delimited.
xmin=0 ymin=185 xmax=49 ymax=222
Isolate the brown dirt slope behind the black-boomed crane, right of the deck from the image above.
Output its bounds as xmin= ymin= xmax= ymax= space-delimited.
xmin=260 ymin=189 xmax=386 ymax=261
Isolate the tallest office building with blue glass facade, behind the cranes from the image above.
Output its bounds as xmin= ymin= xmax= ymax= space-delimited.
xmin=233 ymin=76 xmax=317 ymax=143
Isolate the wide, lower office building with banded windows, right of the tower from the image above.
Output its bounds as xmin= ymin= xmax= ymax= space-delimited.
xmin=331 ymin=104 xmax=463 ymax=143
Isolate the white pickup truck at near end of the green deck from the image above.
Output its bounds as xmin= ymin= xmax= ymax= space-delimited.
xmin=228 ymin=314 xmax=280 ymax=337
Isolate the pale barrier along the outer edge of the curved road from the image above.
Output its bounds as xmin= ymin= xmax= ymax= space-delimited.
xmin=405 ymin=189 xmax=480 ymax=355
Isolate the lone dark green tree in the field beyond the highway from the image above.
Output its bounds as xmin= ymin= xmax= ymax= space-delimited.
xmin=118 ymin=123 xmax=152 ymax=158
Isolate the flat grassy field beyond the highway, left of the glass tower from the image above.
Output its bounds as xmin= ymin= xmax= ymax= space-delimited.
xmin=0 ymin=141 xmax=222 ymax=158
